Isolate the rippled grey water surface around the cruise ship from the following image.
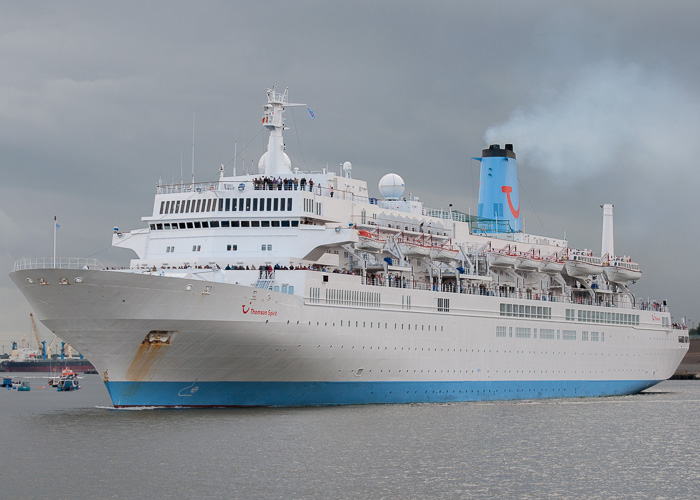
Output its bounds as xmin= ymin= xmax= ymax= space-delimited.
xmin=0 ymin=374 xmax=700 ymax=499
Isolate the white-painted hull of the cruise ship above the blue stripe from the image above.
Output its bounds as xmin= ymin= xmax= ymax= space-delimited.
xmin=11 ymin=269 xmax=687 ymax=406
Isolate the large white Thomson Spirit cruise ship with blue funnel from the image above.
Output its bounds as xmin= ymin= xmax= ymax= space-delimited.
xmin=11 ymin=88 xmax=689 ymax=407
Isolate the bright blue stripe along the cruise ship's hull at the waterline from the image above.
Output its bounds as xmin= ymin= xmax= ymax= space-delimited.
xmin=105 ymin=380 xmax=660 ymax=407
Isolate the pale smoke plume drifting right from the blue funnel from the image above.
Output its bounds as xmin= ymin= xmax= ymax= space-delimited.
xmin=484 ymin=62 xmax=700 ymax=182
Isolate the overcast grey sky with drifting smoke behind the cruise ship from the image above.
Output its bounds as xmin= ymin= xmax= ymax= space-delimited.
xmin=0 ymin=0 xmax=700 ymax=352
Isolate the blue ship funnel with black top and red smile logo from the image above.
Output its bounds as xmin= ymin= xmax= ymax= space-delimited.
xmin=477 ymin=144 xmax=523 ymax=232
